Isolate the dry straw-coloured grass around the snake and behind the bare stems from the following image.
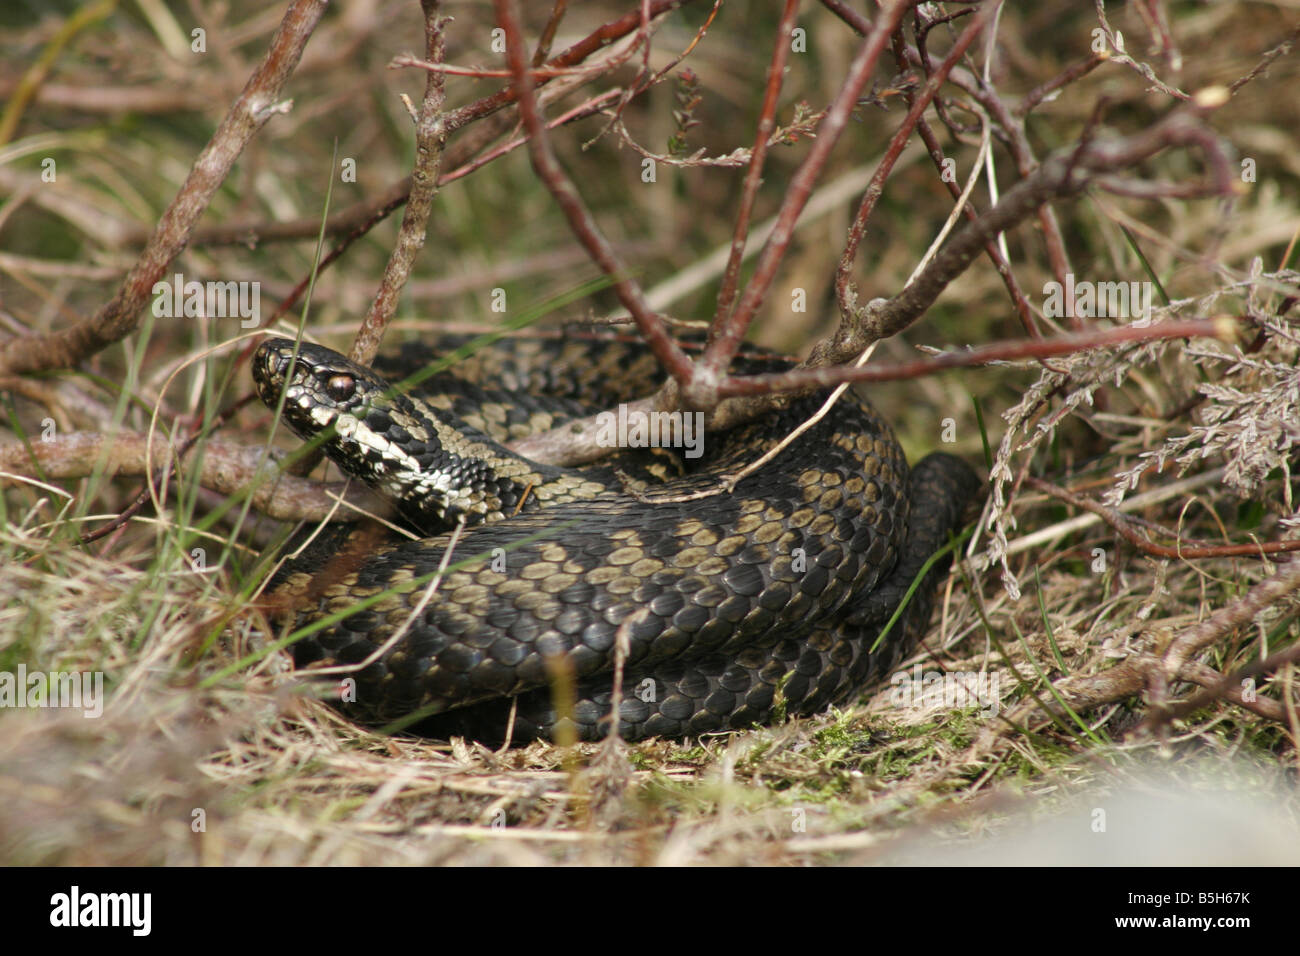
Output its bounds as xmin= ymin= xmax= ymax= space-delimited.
xmin=0 ymin=1 xmax=1300 ymax=865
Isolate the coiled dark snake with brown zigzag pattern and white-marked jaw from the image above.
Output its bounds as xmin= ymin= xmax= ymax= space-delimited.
xmin=252 ymin=333 xmax=979 ymax=741
